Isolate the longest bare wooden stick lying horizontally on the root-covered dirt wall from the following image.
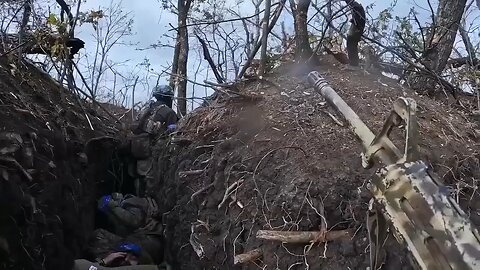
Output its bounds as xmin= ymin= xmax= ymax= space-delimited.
xmin=257 ymin=230 xmax=352 ymax=244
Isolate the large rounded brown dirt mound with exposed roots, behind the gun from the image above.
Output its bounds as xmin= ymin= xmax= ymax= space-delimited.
xmin=154 ymin=58 xmax=480 ymax=269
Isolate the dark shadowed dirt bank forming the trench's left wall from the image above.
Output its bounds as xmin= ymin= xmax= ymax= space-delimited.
xmin=0 ymin=58 xmax=122 ymax=269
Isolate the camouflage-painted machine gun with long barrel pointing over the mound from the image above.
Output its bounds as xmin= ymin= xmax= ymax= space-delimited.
xmin=308 ymin=71 xmax=480 ymax=270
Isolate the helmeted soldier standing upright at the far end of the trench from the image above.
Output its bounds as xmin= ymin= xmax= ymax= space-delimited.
xmin=131 ymin=85 xmax=178 ymax=196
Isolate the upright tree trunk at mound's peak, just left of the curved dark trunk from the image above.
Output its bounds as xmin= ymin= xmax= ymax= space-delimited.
xmin=290 ymin=0 xmax=313 ymax=60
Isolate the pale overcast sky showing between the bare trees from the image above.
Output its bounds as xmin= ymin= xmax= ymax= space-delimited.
xmin=71 ymin=0 xmax=476 ymax=109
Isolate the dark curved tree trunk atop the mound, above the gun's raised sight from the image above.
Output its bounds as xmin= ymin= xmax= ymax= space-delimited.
xmin=344 ymin=0 xmax=366 ymax=69
